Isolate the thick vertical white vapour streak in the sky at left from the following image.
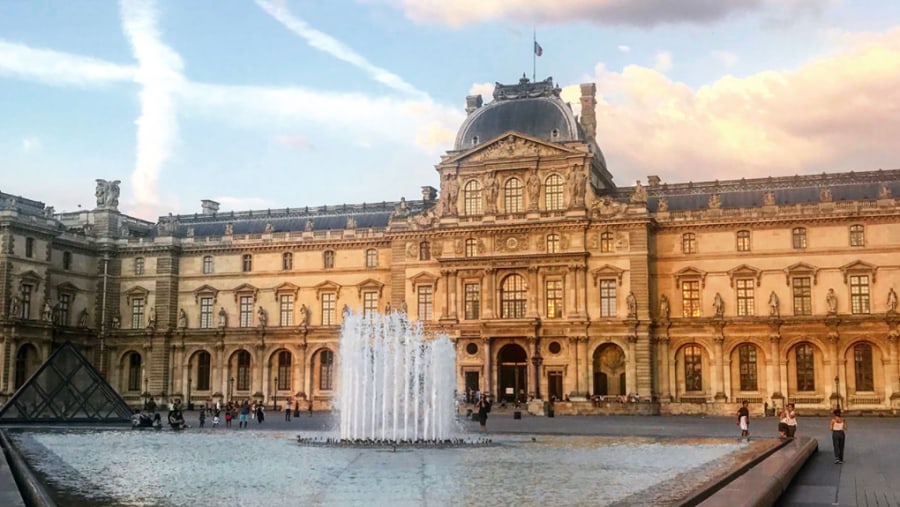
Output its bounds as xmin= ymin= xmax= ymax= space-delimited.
xmin=120 ymin=0 xmax=185 ymax=216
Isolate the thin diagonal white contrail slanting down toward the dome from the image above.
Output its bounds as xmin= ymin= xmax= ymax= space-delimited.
xmin=256 ymin=0 xmax=426 ymax=97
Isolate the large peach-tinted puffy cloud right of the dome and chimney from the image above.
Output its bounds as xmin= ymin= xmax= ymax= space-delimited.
xmin=564 ymin=28 xmax=900 ymax=186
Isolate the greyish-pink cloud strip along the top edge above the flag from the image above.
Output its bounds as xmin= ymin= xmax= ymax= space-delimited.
xmin=369 ymin=0 xmax=835 ymax=27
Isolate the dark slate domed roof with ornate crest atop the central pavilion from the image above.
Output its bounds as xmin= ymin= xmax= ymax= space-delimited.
xmin=455 ymin=77 xmax=584 ymax=150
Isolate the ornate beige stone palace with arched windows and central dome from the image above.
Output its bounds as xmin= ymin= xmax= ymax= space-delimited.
xmin=0 ymin=78 xmax=900 ymax=414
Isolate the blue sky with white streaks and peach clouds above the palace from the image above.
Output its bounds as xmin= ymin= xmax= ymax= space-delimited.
xmin=0 ymin=0 xmax=900 ymax=221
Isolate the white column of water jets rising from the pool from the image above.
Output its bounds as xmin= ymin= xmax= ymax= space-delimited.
xmin=336 ymin=312 xmax=456 ymax=442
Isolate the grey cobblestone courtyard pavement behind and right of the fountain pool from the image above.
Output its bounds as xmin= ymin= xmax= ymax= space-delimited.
xmin=179 ymin=409 xmax=900 ymax=507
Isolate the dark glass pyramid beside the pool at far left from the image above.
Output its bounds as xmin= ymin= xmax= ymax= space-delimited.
xmin=0 ymin=342 xmax=132 ymax=424
